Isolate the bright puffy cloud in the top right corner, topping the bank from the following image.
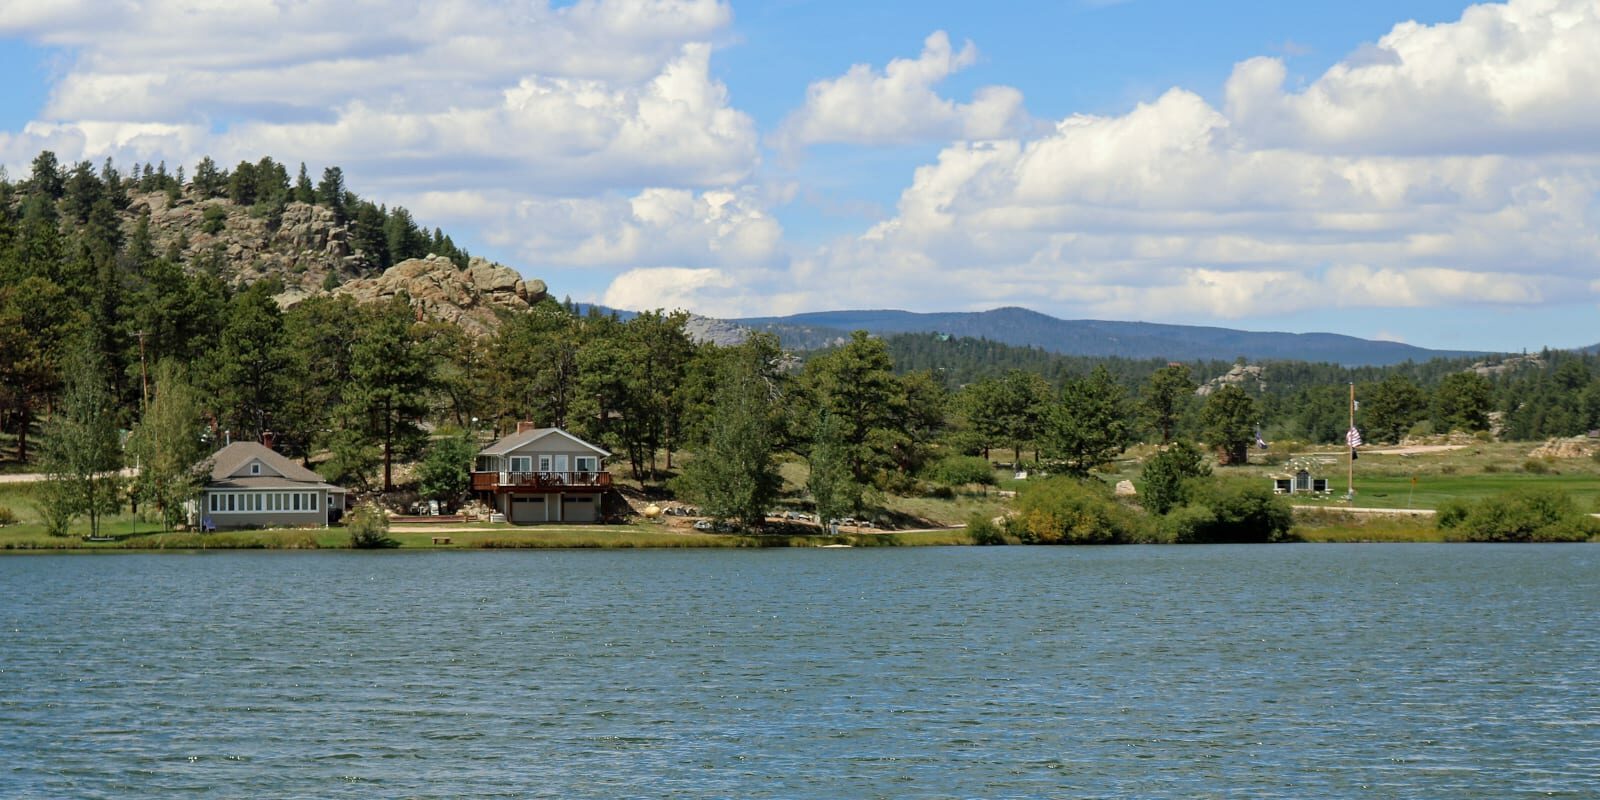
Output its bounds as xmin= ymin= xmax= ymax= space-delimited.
xmin=1226 ymin=0 xmax=1600 ymax=154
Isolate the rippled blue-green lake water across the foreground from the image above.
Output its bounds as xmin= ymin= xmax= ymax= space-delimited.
xmin=0 ymin=544 xmax=1600 ymax=798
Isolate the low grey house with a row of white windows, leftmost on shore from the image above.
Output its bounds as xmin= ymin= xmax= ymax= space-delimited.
xmin=195 ymin=434 xmax=346 ymax=530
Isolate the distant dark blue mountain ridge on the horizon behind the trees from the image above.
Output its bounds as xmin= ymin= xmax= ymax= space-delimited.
xmin=731 ymin=307 xmax=1478 ymax=366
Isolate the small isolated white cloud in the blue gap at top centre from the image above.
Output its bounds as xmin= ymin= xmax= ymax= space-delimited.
xmin=774 ymin=30 xmax=1026 ymax=150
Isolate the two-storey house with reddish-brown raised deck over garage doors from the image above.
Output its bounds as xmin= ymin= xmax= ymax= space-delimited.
xmin=472 ymin=422 xmax=611 ymax=525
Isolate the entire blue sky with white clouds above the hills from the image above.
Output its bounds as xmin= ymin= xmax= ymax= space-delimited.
xmin=0 ymin=0 xmax=1600 ymax=352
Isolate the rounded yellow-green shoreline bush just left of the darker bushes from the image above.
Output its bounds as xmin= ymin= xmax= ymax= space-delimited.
xmin=1006 ymin=477 xmax=1146 ymax=544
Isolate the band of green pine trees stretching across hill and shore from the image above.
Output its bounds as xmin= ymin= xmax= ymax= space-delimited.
xmin=0 ymin=154 xmax=1600 ymax=534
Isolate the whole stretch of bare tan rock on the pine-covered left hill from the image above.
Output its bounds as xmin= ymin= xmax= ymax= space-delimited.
xmin=125 ymin=192 xmax=547 ymax=334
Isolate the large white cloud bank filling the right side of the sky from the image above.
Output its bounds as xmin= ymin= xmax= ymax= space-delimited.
xmin=720 ymin=0 xmax=1600 ymax=320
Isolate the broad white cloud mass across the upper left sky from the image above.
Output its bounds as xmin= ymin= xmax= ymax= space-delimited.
xmin=0 ymin=0 xmax=758 ymax=194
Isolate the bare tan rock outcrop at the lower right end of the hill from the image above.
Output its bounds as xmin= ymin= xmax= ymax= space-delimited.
xmin=324 ymin=256 xmax=547 ymax=336
